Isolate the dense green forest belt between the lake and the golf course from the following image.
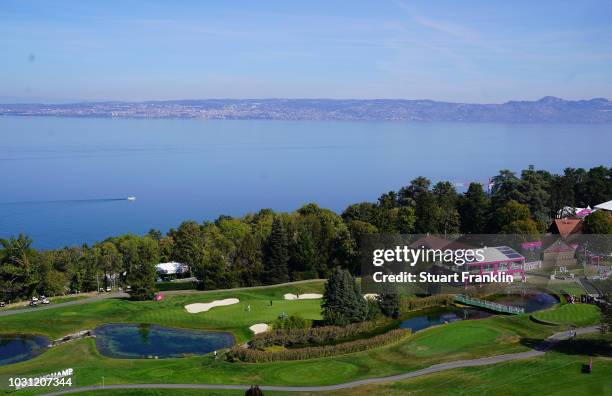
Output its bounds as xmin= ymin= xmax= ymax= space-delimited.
xmin=0 ymin=166 xmax=612 ymax=301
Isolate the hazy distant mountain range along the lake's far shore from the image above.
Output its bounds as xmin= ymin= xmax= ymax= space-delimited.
xmin=0 ymin=96 xmax=612 ymax=123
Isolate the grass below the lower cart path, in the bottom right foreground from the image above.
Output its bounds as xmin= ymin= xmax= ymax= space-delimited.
xmin=21 ymin=337 xmax=612 ymax=396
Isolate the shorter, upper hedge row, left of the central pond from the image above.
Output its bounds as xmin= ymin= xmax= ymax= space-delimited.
xmin=251 ymin=322 xmax=376 ymax=349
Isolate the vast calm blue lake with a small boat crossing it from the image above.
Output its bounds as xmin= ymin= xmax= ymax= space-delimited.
xmin=0 ymin=117 xmax=612 ymax=248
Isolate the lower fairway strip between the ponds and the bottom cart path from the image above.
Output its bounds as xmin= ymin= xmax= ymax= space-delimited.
xmin=0 ymin=316 xmax=550 ymax=394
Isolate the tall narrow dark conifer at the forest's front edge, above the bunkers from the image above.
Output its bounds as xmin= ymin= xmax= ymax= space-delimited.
xmin=264 ymin=216 xmax=289 ymax=284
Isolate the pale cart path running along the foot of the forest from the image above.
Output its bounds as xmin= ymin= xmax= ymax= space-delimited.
xmin=0 ymin=279 xmax=324 ymax=317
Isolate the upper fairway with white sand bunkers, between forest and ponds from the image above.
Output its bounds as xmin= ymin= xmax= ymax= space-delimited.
xmin=0 ymin=281 xmax=323 ymax=341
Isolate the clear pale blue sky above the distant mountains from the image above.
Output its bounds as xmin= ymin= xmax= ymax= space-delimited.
xmin=0 ymin=0 xmax=612 ymax=103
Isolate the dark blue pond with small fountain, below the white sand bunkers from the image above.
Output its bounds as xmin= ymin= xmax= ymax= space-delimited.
xmin=94 ymin=324 xmax=235 ymax=359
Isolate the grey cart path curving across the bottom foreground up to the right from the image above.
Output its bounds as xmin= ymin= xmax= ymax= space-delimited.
xmin=45 ymin=326 xmax=599 ymax=396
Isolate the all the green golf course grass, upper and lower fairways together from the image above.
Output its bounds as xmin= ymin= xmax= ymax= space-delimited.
xmin=0 ymin=281 xmax=612 ymax=395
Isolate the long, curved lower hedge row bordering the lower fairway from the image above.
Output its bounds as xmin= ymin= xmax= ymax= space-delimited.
xmin=226 ymin=329 xmax=411 ymax=363
